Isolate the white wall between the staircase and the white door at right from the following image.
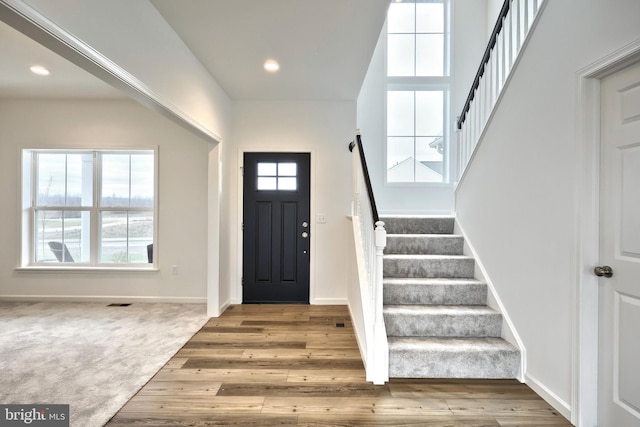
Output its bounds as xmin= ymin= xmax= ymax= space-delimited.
xmin=456 ymin=0 xmax=640 ymax=422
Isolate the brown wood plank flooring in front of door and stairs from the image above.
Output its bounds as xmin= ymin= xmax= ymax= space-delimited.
xmin=107 ymin=305 xmax=571 ymax=427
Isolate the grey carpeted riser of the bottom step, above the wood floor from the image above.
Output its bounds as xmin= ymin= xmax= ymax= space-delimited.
xmin=389 ymin=350 xmax=520 ymax=379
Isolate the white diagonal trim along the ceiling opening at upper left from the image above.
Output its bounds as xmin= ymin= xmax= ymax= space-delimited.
xmin=0 ymin=0 xmax=221 ymax=143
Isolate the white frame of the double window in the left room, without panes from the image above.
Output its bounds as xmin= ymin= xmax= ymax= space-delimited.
xmin=18 ymin=146 xmax=159 ymax=271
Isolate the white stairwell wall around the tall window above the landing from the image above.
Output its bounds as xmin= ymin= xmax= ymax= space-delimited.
xmin=357 ymin=0 xmax=487 ymax=214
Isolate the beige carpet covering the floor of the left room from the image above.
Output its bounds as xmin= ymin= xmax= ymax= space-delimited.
xmin=0 ymin=302 xmax=207 ymax=427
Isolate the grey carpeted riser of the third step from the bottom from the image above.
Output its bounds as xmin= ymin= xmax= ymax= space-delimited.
xmin=383 ymin=284 xmax=487 ymax=305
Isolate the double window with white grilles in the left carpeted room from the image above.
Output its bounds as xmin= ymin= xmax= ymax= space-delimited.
xmin=22 ymin=150 xmax=156 ymax=267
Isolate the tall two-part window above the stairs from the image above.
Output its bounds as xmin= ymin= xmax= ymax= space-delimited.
xmin=386 ymin=0 xmax=450 ymax=183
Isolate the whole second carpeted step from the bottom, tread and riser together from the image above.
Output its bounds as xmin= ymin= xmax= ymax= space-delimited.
xmin=383 ymin=305 xmax=502 ymax=337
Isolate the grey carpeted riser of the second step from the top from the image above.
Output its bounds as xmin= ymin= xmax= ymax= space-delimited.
xmin=385 ymin=236 xmax=464 ymax=255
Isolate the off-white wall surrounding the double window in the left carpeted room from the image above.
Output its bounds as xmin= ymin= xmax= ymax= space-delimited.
xmin=0 ymin=99 xmax=208 ymax=302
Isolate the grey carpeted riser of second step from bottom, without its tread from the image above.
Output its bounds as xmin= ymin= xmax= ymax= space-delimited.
xmin=384 ymin=313 xmax=502 ymax=338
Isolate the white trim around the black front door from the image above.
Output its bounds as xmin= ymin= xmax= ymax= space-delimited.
xmin=233 ymin=145 xmax=317 ymax=305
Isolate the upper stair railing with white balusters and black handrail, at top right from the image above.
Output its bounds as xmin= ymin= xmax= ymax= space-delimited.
xmin=457 ymin=0 xmax=546 ymax=181
